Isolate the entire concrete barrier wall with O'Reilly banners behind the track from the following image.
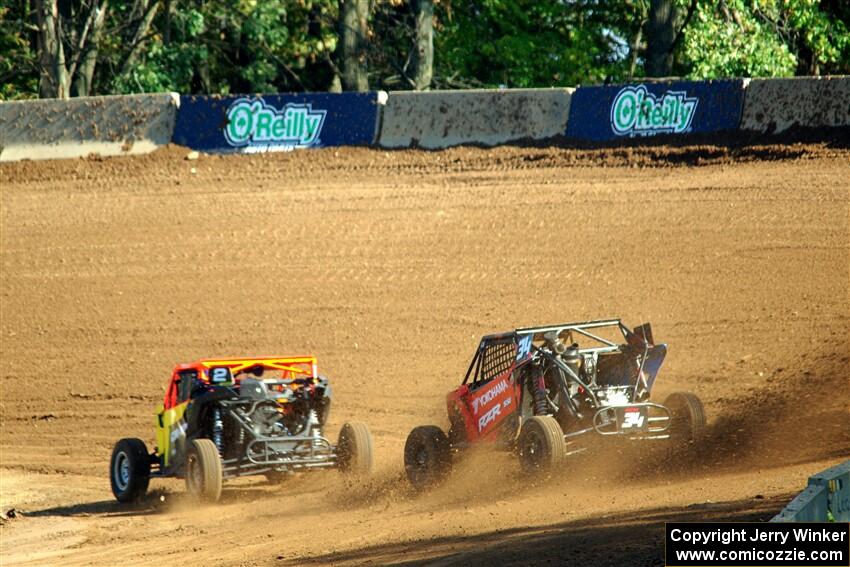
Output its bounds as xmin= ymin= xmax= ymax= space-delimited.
xmin=0 ymin=76 xmax=850 ymax=161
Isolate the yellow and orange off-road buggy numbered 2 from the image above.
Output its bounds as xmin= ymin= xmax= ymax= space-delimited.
xmin=109 ymin=356 xmax=372 ymax=502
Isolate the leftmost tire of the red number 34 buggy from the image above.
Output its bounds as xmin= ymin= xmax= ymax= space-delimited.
xmin=404 ymin=425 xmax=452 ymax=490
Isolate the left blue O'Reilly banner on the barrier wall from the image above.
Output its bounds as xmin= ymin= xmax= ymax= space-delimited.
xmin=172 ymin=92 xmax=378 ymax=153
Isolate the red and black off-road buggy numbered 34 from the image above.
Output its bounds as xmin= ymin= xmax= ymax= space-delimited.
xmin=404 ymin=319 xmax=705 ymax=488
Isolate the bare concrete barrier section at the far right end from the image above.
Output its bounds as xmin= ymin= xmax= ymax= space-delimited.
xmin=740 ymin=76 xmax=850 ymax=134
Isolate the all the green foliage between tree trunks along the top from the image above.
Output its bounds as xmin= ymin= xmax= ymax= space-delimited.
xmin=0 ymin=0 xmax=850 ymax=99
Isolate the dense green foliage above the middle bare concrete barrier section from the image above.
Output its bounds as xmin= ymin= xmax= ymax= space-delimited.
xmin=435 ymin=0 xmax=640 ymax=87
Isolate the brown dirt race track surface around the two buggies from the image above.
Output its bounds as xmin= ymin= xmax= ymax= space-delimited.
xmin=0 ymin=146 xmax=850 ymax=565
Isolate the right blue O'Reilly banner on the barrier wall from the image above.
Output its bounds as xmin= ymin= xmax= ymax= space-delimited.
xmin=566 ymin=79 xmax=744 ymax=142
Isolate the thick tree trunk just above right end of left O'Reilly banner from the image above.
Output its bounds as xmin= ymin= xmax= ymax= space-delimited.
xmin=339 ymin=0 xmax=369 ymax=92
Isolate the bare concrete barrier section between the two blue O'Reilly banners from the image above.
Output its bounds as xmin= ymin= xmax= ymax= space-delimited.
xmin=378 ymin=89 xmax=573 ymax=149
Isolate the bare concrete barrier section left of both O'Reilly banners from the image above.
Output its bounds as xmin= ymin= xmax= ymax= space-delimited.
xmin=0 ymin=93 xmax=180 ymax=161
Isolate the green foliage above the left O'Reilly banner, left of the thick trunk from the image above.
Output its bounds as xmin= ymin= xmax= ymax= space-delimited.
xmin=106 ymin=0 xmax=336 ymax=94
